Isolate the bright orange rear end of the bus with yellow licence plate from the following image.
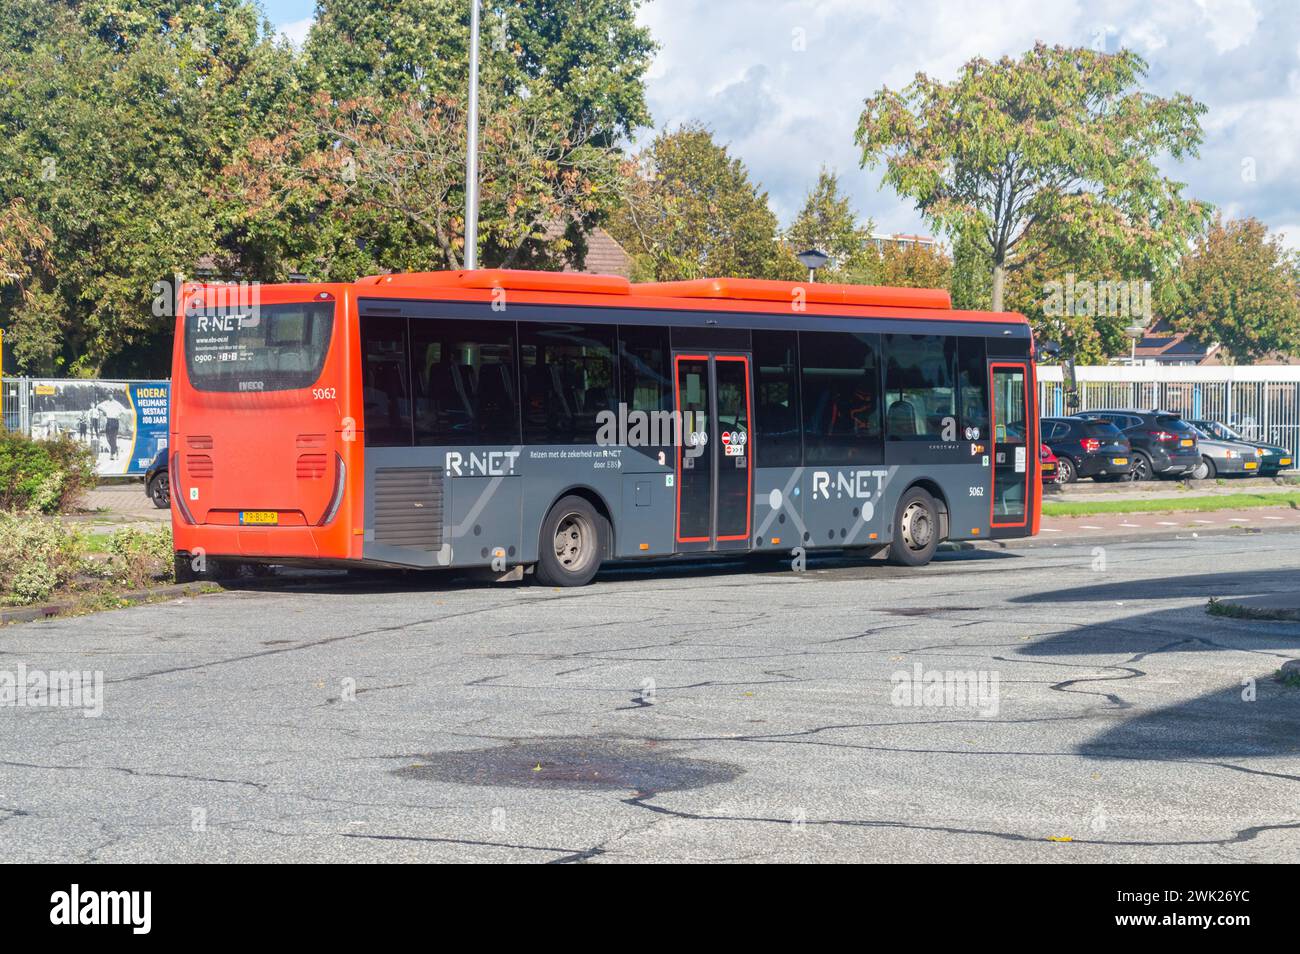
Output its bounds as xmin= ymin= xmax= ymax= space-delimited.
xmin=168 ymin=285 xmax=363 ymax=561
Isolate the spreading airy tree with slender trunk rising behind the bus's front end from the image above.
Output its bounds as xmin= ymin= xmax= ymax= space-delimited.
xmin=857 ymin=44 xmax=1206 ymax=311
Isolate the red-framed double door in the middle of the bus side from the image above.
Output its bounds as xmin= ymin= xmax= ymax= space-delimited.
xmin=673 ymin=352 xmax=754 ymax=551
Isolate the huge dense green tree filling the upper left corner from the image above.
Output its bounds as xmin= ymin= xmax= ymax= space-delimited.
xmin=0 ymin=0 xmax=291 ymax=374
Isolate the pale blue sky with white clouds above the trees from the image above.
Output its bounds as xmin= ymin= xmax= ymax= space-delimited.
xmin=264 ymin=0 xmax=1300 ymax=248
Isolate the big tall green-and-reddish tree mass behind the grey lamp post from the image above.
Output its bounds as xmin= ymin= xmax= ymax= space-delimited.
xmin=257 ymin=0 xmax=654 ymax=278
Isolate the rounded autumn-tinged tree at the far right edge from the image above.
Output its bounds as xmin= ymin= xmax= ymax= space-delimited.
xmin=1165 ymin=216 xmax=1300 ymax=361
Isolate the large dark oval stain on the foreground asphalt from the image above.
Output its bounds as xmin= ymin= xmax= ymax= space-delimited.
xmin=393 ymin=737 xmax=744 ymax=797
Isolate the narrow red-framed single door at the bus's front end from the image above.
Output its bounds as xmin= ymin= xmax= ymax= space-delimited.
xmin=989 ymin=361 xmax=1039 ymax=530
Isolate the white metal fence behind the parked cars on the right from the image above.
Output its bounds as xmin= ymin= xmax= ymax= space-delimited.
xmin=1039 ymin=365 xmax=1300 ymax=454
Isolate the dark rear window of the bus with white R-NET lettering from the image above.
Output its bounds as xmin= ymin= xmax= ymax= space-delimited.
xmin=185 ymin=302 xmax=334 ymax=391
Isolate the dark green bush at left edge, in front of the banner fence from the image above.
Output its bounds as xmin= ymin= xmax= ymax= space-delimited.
xmin=0 ymin=430 xmax=95 ymax=513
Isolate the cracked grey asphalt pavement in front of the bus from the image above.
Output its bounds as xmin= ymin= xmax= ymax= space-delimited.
xmin=0 ymin=533 xmax=1300 ymax=862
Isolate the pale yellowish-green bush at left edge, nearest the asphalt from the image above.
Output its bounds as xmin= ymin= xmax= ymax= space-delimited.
xmin=0 ymin=512 xmax=94 ymax=606
